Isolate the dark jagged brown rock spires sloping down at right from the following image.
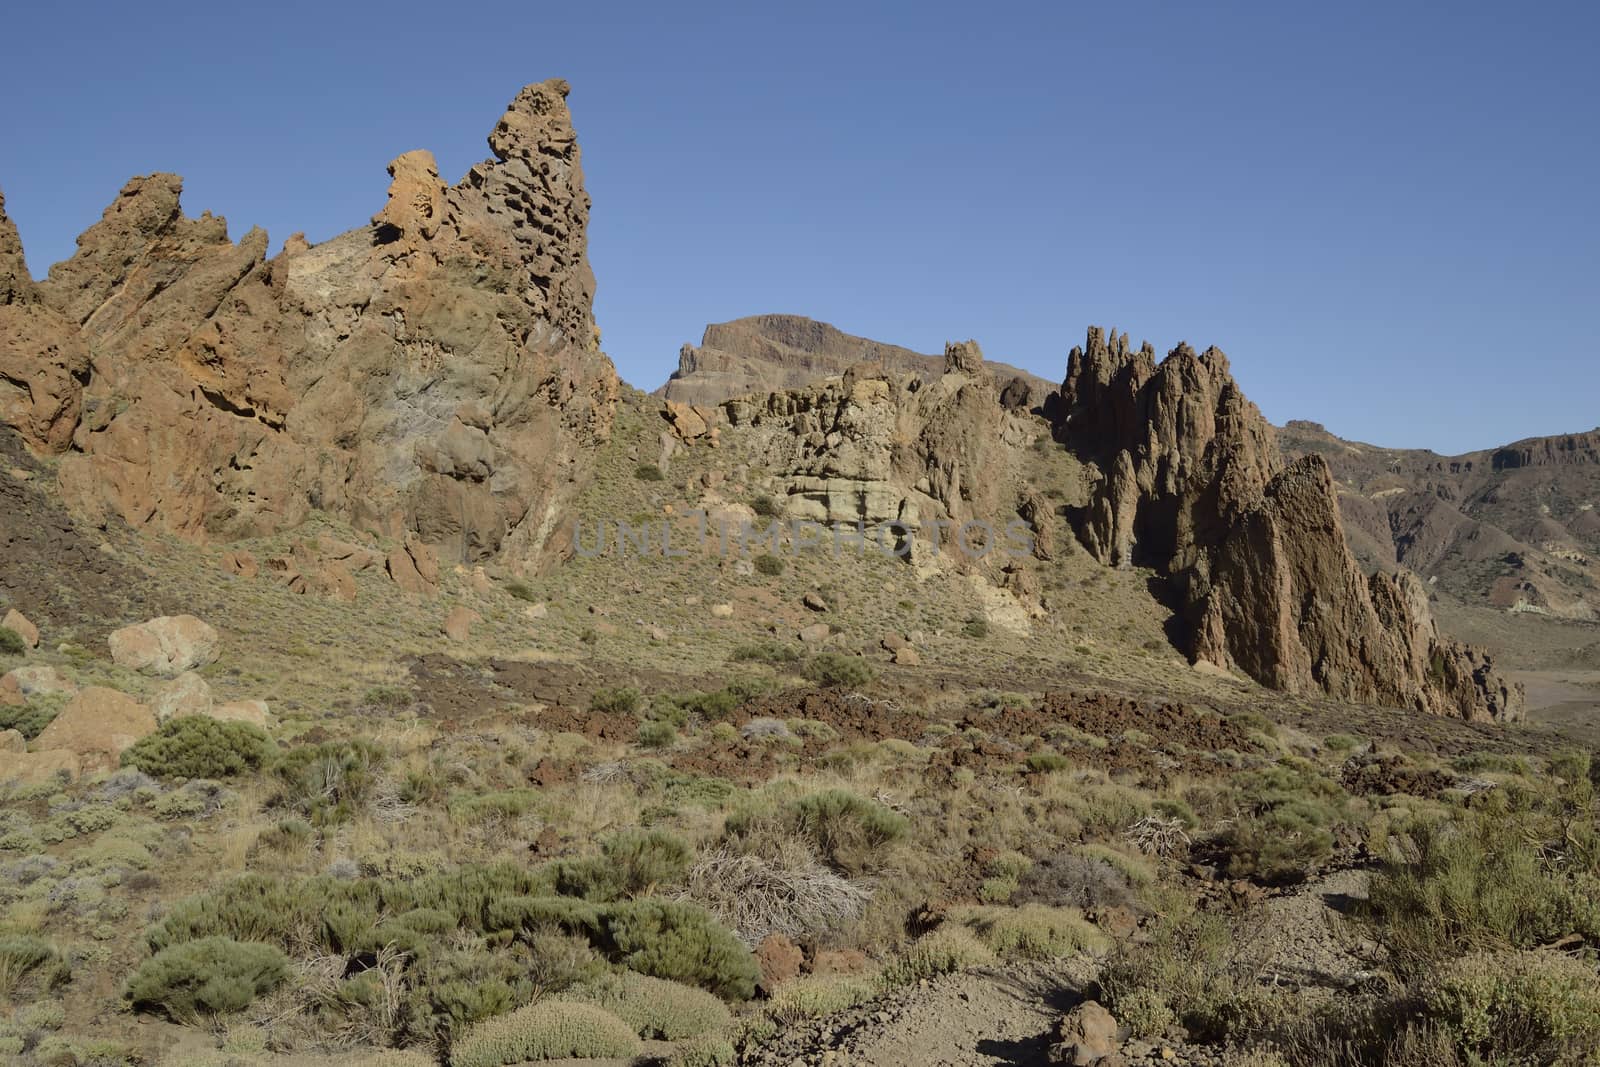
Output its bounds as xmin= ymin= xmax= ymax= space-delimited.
xmin=1046 ymin=328 xmax=1522 ymax=720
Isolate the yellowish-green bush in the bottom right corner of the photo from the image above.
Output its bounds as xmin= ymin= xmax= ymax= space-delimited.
xmin=1424 ymin=952 xmax=1600 ymax=1064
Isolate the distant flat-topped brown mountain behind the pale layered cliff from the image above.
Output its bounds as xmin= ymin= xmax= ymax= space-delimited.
xmin=654 ymin=315 xmax=1053 ymax=406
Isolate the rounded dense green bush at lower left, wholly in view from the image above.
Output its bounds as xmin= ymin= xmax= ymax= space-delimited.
xmin=123 ymin=937 xmax=290 ymax=1022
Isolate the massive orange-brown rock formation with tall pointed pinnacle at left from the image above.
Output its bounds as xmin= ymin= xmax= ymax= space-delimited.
xmin=0 ymin=80 xmax=618 ymax=569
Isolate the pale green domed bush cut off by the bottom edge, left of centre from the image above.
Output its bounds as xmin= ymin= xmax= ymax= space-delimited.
xmin=450 ymin=1000 xmax=638 ymax=1067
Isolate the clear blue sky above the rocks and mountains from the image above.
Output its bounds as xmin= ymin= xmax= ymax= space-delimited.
xmin=0 ymin=0 xmax=1600 ymax=451
